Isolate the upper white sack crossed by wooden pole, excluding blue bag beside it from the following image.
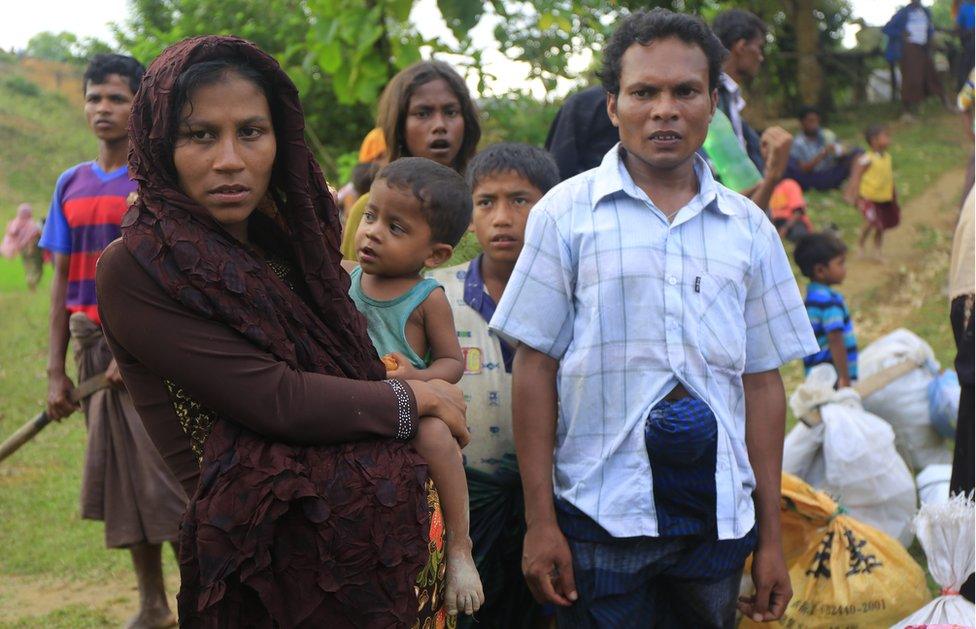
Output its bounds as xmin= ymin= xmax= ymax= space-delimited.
xmin=858 ymin=328 xmax=952 ymax=470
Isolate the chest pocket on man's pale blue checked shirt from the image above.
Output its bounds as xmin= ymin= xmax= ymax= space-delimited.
xmin=695 ymin=273 xmax=746 ymax=373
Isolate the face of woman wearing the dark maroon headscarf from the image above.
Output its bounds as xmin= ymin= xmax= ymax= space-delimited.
xmin=173 ymin=72 xmax=277 ymax=242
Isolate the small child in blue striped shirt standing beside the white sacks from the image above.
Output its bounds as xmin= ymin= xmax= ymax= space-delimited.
xmin=793 ymin=234 xmax=857 ymax=388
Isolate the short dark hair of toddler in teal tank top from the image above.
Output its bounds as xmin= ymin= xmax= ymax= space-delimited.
xmin=374 ymin=157 xmax=472 ymax=247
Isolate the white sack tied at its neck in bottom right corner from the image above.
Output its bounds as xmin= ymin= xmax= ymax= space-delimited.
xmin=893 ymin=494 xmax=976 ymax=629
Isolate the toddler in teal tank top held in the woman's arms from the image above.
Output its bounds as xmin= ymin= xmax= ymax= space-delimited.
xmin=349 ymin=157 xmax=484 ymax=614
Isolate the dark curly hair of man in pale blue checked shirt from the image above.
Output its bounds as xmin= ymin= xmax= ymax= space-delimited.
xmin=600 ymin=7 xmax=727 ymax=94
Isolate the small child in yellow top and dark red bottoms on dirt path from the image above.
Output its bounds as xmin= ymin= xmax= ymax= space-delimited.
xmin=844 ymin=124 xmax=901 ymax=260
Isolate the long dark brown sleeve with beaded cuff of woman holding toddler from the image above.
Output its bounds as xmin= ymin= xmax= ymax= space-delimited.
xmin=97 ymin=242 xmax=416 ymax=445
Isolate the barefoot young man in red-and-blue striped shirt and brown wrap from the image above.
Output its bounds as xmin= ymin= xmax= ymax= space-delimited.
xmin=38 ymin=54 xmax=186 ymax=627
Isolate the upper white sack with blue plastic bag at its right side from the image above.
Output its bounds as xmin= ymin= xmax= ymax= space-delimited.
xmin=858 ymin=329 xmax=959 ymax=470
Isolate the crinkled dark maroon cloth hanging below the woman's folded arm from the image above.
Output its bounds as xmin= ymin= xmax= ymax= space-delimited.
xmin=178 ymin=420 xmax=450 ymax=629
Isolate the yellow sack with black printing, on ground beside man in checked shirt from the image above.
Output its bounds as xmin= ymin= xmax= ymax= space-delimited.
xmin=739 ymin=474 xmax=931 ymax=629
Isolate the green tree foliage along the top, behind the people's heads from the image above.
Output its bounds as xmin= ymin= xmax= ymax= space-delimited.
xmin=107 ymin=0 xmax=850 ymax=173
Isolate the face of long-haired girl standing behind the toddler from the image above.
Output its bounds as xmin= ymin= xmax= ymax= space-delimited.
xmin=403 ymin=79 xmax=464 ymax=168
